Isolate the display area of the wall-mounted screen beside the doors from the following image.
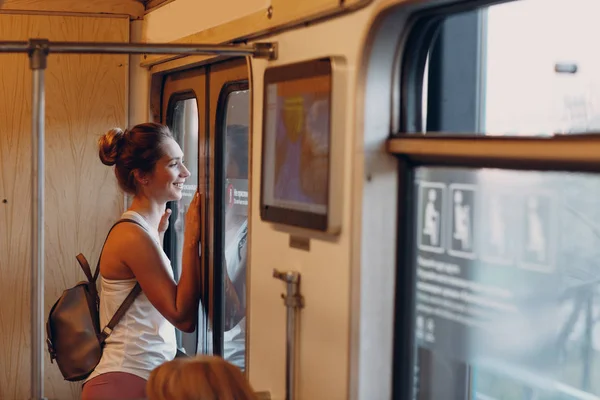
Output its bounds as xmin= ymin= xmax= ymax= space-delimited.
xmin=263 ymin=74 xmax=331 ymax=215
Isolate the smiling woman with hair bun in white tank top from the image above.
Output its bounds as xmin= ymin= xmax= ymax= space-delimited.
xmin=82 ymin=123 xmax=201 ymax=400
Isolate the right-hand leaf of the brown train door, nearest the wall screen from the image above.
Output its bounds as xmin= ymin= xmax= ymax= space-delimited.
xmin=209 ymin=60 xmax=250 ymax=370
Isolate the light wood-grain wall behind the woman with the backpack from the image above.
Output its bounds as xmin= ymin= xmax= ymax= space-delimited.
xmin=0 ymin=14 xmax=129 ymax=399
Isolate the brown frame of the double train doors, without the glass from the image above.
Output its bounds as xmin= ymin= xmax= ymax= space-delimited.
xmin=155 ymin=58 xmax=252 ymax=375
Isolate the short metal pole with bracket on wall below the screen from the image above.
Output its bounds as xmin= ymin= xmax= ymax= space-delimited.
xmin=273 ymin=270 xmax=304 ymax=400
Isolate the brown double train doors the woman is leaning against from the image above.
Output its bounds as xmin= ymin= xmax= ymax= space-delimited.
xmin=162 ymin=59 xmax=250 ymax=369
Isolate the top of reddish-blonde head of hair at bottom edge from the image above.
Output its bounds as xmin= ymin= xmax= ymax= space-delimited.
xmin=146 ymin=355 xmax=256 ymax=400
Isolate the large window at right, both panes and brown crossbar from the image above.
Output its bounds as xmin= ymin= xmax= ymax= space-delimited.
xmin=388 ymin=0 xmax=600 ymax=400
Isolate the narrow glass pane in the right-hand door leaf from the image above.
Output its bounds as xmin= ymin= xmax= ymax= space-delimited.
xmin=221 ymin=90 xmax=250 ymax=369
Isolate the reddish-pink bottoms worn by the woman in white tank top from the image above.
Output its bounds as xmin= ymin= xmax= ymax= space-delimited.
xmin=81 ymin=372 xmax=146 ymax=400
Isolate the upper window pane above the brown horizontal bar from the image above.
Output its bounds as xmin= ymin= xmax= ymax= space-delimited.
xmin=423 ymin=0 xmax=600 ymax=136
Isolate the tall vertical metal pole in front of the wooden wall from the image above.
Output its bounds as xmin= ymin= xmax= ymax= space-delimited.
xmin=29 ymin=40 xmax=48 ymax=400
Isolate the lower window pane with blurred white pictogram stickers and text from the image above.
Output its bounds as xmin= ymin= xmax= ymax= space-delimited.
xmin=411 ymin=167 xmax=600 ymax=400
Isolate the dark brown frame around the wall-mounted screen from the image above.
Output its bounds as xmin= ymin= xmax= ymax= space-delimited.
xmin=260 ymin=58 xmax=334 ymax=232
